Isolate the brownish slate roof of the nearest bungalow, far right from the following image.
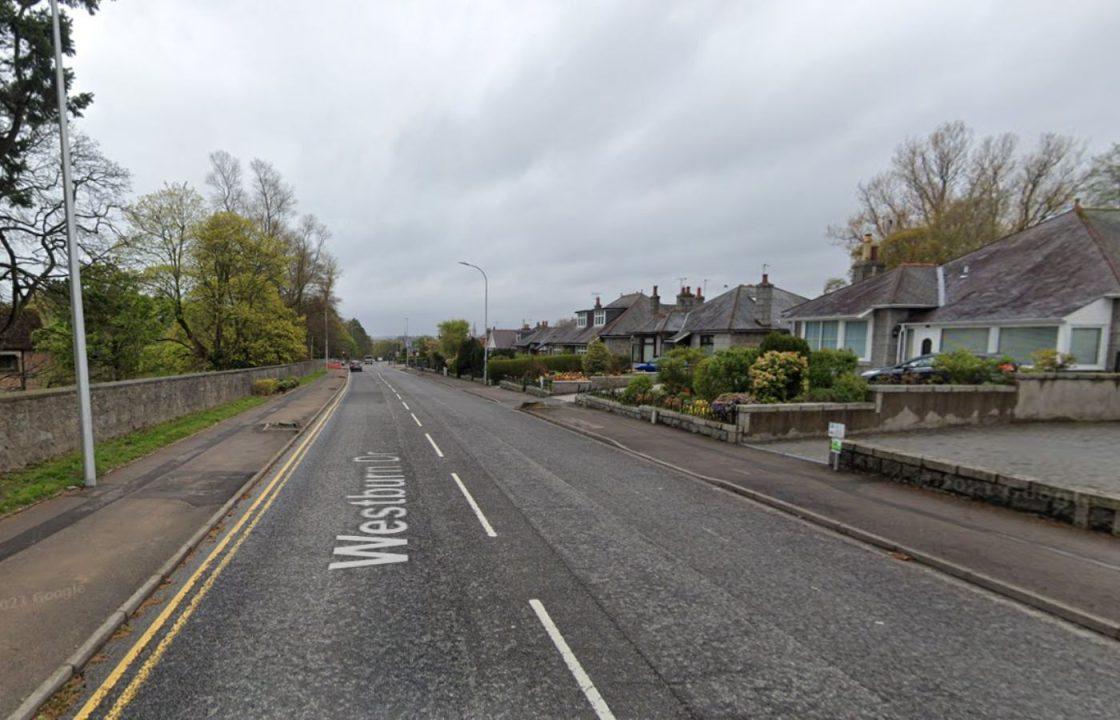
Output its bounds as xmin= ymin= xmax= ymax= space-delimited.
xmin=785 ymin=208 xmax=1120 ymax=322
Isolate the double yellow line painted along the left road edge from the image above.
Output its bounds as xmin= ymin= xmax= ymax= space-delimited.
xmin=74 ymin=375 xmax=349 ymax=720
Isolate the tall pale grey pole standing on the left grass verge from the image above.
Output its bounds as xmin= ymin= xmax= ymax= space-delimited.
xmin=50 ymin=0 xmax=97 ymax=487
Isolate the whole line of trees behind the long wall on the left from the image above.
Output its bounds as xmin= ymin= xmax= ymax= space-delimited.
xmin=0 ymin=0 xmax=372 ymax=384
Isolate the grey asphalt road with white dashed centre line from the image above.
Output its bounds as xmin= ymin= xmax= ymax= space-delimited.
xmin=73 ymin=366 xmax=1120 ymax=719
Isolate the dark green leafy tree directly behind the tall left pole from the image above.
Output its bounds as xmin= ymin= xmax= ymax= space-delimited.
xmin=34 ymin=263 xmax=169 ymax=385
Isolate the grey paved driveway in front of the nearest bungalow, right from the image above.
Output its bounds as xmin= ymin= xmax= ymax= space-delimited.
xmin=758 ymin=422 xmax=1120 ymax=495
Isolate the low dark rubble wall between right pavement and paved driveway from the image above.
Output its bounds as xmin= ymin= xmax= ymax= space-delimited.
xmin=840 ymin=440 xmax=1120 ymax=535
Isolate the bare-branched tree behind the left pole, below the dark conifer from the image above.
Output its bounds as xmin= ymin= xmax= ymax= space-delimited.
xmin=0 ymin=133 xmax=129 ymax=334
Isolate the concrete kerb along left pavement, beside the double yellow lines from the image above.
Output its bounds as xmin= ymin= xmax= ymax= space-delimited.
xmin=8 ymin=377 xmax=349 ymax=720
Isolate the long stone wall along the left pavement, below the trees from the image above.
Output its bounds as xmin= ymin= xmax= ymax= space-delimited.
xmin=0 ymin=361 xmax=323 ymax=471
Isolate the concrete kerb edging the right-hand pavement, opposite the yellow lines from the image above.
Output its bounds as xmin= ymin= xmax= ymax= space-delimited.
xmin=526 ymin=405 xmax=1120 ymax=640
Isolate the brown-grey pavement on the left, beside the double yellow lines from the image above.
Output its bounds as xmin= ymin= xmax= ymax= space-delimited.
xmin=0 ymin=374 xmax=345 ymax=717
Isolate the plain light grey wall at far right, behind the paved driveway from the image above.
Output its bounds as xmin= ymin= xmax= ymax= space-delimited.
xmin=1015 ymin=373 xmax=1120 ymax=421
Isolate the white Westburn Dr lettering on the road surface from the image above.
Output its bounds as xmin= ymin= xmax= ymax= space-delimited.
xmin=327 ymin=452 xmax=409 ymax=570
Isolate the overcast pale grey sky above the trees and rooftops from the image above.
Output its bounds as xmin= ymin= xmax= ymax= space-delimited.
xmin=69 ymin=0 xmax=1120 ymax=335
